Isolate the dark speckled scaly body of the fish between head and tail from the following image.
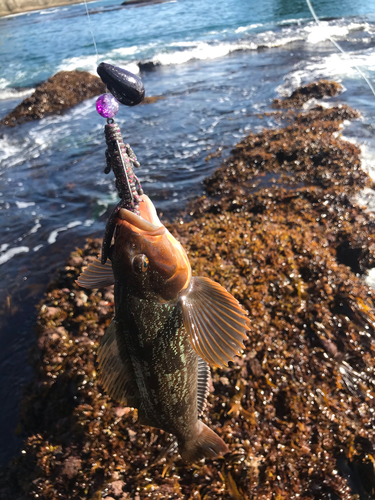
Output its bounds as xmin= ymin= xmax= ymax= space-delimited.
xmin=116 ymin=296 xmax=198 ymax=437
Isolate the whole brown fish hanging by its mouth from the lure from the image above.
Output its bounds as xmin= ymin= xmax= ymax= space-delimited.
xmin=78 ymin=195 xmax=249 ymax=462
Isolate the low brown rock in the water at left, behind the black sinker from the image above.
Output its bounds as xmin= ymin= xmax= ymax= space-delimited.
xmin=0 ymin=70 xmax=164 ymax=127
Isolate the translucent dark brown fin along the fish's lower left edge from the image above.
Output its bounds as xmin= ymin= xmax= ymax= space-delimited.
xmin=97 ymin=320 xmax=139 ymax=408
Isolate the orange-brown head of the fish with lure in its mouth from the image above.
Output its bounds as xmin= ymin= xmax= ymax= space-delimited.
xmin=111 ymin=195 xmax=191 ymax=302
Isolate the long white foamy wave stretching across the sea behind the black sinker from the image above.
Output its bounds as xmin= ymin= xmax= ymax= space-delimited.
xmin=58 ymin=19 xmax=372 ymax=73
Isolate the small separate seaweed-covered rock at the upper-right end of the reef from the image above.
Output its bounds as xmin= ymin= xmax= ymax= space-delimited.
xmin=272 ymin=80 xmax=342 ymax=108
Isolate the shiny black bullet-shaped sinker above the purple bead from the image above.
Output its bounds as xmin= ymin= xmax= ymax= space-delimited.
xmin=97 ymin=63 xmax=145 ymax=106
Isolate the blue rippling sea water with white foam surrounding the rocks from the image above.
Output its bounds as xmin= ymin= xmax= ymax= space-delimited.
xmin=0 ymin=0 xmax=375 ymax=463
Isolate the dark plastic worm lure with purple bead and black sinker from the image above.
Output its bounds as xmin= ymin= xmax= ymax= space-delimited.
xmin=96 ymin=63 xmax=145 ymax=264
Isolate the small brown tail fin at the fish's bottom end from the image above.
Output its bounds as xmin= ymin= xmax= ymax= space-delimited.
xmin=179 ymin=420 xmax=229 ymax=463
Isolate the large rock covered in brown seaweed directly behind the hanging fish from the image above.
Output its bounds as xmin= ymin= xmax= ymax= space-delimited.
xmin=0 ymin=84 xmax=375 ymax=500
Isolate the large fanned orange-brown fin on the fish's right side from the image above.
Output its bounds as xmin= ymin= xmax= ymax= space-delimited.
xmin=180 ymin=277 xmax=250 ymax=366
